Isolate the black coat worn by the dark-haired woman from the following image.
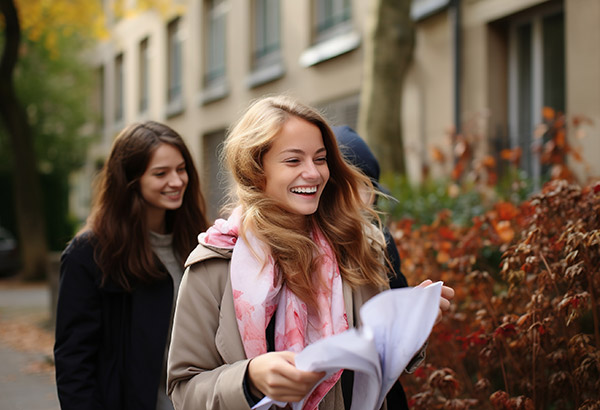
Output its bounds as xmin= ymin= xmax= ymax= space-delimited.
xmin=54 ymin=234 xmax=173 ymax=410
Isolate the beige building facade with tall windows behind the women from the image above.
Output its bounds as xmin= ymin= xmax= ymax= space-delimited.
xmin=73 ymin=0 xmax=600 ymax=223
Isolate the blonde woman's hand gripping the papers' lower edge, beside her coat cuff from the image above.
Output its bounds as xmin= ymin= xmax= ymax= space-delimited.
xmin=248 ymin=352 xmax=325 ymax=402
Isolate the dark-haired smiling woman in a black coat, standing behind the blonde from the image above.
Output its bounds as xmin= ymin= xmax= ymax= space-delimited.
xmin=54 ymin=121 xmax=208 ymax=410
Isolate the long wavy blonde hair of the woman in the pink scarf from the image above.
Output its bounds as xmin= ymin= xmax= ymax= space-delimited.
xmin=223 ymin=96 xmax=387 ymax=306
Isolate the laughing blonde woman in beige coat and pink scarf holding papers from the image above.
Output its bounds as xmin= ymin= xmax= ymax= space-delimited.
xmin=167 ymin=96 xmax=451 ymax=410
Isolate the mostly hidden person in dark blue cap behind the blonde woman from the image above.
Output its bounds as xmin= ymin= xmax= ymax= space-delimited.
xmin=331 ymin=125 xmax=410 ymax=409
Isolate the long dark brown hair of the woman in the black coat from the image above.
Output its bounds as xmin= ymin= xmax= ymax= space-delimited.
xmin=84 ymin=121 xmax=208 ymax=290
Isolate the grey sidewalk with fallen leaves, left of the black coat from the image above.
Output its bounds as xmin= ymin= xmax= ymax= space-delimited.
xmin=0 ymin=279 xmax=60 ymax=410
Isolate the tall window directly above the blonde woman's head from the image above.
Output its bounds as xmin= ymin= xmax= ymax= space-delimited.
xmin=248 ymin=0 xmax=284 ymax=87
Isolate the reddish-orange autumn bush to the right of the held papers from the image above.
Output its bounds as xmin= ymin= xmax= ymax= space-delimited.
xmin=391 ymin=181 xmax=600 ymax=409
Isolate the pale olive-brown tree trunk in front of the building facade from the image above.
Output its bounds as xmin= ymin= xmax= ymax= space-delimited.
xmin=358 ymin=0 xmax=415 ymax=173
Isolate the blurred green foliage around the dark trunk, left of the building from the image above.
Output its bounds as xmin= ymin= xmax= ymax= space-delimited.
xmin=0 ymin=22 xmax=95 ymax=250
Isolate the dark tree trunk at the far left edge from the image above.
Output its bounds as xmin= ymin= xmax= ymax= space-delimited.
xmin=0 ymin=0 xmax=48 ymax=280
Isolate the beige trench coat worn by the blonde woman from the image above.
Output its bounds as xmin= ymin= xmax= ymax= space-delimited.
xmin=167 ymin=245 xmax=386 ymax=410
